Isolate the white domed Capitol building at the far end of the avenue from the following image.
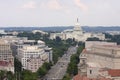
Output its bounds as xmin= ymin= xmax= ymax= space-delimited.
xmin=50 ymin=19 xmax=105 ymax=41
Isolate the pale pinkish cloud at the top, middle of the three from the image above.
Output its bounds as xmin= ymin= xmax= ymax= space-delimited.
xmin=41 ymin=0 xmax=63 ymax=10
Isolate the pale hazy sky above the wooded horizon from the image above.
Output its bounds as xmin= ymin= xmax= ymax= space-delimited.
xmin=0 ymin=0 xmax=120 ymax=27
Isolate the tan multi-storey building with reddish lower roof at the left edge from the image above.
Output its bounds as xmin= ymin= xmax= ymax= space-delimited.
xmin=0 ymin=39 xmax=14 ymax=73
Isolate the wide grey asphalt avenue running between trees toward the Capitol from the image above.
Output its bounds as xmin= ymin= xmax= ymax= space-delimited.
xmin=42 ymin=47 xmax=77 ymax=80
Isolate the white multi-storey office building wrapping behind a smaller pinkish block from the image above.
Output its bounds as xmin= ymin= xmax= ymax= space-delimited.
xmin=17 ymin=45 xmax=48 ymax=69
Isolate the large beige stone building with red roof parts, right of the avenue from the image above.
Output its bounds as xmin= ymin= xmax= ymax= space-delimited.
xmin=78 ymin=41 xmax=120 ymax=80
